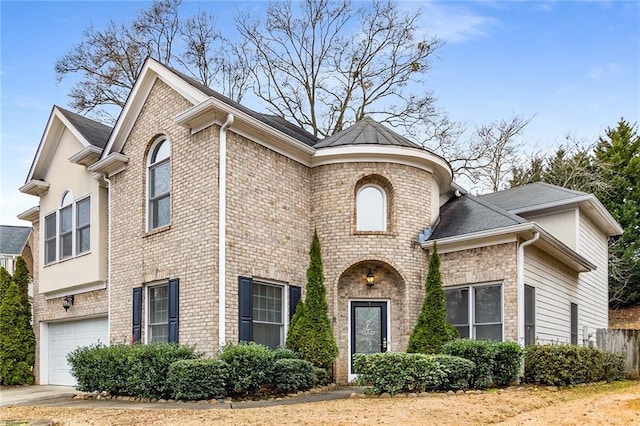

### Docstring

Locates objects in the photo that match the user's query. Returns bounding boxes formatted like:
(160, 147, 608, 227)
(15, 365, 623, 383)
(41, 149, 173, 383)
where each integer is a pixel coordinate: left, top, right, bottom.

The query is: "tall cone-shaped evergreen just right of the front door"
(407, 243, 451, 354)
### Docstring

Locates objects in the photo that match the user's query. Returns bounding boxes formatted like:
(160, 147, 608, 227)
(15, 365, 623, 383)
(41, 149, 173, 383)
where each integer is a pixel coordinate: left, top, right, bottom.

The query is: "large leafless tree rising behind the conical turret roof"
(236, 0, 442, 136)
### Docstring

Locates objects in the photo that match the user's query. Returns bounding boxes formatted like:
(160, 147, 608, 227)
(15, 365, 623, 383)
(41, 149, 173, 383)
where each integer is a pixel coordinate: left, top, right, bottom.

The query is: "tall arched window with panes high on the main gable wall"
(147, 137, 171, 230)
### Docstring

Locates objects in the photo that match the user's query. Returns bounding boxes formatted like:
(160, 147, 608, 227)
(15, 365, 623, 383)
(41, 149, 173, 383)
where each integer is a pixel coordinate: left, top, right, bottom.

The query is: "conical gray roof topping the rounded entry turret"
(314, 117, 424, 149)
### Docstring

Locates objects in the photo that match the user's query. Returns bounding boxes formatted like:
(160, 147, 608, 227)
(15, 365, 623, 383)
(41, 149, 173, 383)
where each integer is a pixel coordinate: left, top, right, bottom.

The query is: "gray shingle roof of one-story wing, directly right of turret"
(429, 195, 527, 240)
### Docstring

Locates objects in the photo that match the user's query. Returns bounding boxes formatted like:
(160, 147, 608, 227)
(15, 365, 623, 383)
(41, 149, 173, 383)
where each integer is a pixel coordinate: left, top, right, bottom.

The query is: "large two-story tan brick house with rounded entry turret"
(20, 59, 620, 384)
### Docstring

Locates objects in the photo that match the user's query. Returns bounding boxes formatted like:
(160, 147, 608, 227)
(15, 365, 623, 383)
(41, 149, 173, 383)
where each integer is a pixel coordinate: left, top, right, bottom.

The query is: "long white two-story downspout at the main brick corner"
(218, 114, 233, 347)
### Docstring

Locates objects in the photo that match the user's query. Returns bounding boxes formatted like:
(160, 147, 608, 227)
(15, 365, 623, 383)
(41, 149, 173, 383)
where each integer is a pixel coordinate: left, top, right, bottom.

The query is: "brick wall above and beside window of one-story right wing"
(440, 242, 518, 342)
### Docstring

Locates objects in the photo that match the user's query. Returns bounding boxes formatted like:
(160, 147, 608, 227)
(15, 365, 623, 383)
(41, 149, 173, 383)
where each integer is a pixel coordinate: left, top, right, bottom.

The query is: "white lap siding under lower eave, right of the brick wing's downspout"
(524, 247, 584, 344)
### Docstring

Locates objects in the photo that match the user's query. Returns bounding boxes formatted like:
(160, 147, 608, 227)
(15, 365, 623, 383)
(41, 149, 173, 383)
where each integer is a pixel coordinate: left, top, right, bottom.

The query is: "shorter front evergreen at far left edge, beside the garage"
(0, 281, 35, 385)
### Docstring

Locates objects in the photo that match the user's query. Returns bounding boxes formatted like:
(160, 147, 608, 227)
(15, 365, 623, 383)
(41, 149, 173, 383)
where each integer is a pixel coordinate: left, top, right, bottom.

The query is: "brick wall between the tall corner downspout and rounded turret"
(226, 131, 313, 342)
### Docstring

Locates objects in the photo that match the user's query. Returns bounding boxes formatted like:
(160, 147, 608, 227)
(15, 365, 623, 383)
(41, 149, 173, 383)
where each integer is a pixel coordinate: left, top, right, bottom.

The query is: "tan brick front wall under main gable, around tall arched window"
(110, 80, 218, 356)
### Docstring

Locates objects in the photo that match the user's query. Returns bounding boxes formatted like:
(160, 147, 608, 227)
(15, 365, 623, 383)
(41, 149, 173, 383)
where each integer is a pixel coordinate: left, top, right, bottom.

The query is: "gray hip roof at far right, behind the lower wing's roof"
(478, 182, 589, 211)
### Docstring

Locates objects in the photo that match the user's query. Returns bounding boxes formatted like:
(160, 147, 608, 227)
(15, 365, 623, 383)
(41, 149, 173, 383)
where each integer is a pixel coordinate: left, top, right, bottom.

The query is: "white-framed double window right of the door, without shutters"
(444, 284, 502, 342)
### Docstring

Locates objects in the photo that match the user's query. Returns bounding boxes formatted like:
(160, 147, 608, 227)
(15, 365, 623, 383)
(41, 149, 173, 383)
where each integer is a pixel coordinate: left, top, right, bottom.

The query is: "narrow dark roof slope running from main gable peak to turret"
(163, 64, 318, 146)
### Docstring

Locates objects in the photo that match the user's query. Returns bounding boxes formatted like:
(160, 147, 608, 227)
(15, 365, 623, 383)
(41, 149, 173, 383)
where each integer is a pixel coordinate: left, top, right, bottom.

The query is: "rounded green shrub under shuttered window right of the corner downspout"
(220, 342, 275, 396)
